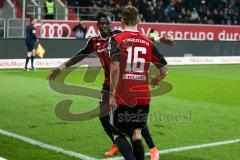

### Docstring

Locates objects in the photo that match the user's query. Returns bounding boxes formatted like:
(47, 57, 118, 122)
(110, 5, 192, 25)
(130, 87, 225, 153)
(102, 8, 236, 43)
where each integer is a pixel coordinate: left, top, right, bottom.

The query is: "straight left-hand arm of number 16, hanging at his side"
(109, 37, 120, 108)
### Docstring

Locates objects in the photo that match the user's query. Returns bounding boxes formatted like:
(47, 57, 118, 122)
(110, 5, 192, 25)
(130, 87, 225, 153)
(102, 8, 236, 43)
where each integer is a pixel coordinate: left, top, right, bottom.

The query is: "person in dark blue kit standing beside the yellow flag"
(24, 18, 37, 71)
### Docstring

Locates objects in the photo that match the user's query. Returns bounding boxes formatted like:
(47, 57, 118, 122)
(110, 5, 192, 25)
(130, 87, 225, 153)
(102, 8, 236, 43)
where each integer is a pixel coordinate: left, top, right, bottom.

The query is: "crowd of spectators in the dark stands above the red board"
(67, 0, 240, 25)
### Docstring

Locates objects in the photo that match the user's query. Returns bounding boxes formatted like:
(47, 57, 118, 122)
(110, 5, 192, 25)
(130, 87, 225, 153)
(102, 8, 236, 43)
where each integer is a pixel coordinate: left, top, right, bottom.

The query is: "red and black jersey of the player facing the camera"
(74, 30, 121, 85)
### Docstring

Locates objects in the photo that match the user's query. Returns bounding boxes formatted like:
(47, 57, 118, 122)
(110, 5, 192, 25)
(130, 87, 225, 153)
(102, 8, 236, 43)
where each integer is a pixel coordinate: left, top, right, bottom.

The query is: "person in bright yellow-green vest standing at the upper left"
(44, 0, 56, 19)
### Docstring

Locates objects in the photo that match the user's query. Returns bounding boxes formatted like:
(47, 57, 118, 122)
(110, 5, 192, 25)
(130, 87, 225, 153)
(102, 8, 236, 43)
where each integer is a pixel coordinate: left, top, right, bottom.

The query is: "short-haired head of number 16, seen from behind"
(122, 6, 139, 26)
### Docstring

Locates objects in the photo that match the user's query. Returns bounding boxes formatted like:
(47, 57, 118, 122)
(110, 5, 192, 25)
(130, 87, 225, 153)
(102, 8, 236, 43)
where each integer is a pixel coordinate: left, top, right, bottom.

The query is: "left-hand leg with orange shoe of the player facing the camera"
(99, 85, 118, 156)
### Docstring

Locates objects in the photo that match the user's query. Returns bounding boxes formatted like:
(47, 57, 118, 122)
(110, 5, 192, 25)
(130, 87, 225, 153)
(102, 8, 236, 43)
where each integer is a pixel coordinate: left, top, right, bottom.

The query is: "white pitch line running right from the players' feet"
(101, 138, 240, 160)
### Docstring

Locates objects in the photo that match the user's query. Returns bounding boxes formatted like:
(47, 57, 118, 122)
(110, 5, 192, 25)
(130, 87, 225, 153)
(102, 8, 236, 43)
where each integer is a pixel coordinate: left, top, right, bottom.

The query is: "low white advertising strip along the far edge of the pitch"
(0, 56, 240, 69)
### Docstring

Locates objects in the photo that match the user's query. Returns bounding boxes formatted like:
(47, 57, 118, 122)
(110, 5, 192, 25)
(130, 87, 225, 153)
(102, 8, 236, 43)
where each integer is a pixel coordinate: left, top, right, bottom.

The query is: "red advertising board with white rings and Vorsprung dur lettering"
(34, 21, 240, 41)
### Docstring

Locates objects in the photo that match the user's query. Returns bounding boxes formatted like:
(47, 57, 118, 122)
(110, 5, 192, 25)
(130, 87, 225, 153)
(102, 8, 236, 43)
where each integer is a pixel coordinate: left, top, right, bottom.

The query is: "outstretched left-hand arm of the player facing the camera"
(48, 38, 94, 80)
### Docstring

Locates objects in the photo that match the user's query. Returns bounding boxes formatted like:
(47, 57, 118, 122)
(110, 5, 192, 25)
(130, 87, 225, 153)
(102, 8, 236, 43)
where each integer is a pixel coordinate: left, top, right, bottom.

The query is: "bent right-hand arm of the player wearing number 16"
(150, 45, 168, 88)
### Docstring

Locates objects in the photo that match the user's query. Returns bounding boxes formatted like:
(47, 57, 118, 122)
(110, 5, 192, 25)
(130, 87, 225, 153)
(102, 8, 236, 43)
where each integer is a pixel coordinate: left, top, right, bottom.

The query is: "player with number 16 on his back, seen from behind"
(109, 6, 167, 160)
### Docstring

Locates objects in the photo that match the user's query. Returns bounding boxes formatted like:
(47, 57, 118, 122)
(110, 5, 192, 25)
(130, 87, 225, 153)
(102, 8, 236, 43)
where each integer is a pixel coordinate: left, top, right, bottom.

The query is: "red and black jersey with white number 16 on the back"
(110, 31, 167, 106)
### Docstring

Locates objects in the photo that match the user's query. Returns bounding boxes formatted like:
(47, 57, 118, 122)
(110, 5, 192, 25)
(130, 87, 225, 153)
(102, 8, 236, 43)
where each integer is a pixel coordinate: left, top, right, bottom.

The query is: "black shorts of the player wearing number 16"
(110, 105, 149, 137)
